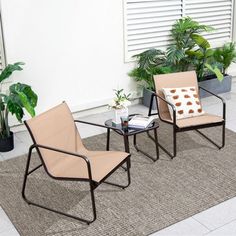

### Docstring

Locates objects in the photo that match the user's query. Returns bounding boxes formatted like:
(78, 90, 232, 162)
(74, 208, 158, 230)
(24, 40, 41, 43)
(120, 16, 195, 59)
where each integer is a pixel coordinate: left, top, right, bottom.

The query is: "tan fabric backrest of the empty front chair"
(25, 102, 84, 173)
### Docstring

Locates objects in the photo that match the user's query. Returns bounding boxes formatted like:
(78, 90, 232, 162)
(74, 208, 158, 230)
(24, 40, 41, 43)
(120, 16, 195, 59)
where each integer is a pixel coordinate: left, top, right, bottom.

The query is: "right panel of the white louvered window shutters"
(184, 0, 233, 47)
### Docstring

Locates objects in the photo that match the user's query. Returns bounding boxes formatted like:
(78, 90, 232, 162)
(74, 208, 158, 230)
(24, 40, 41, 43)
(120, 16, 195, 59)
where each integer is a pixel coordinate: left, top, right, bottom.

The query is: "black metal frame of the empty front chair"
(22, 120, 131, 225)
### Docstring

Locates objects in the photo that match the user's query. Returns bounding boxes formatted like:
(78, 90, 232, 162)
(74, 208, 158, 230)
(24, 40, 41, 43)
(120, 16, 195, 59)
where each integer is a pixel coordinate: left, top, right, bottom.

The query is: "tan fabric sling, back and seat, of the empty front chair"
(27, 103, 129, 182)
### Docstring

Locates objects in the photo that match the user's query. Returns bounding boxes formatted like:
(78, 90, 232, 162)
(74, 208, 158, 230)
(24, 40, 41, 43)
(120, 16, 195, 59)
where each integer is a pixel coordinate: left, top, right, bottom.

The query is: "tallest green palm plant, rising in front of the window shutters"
(167, 17, 213, 71)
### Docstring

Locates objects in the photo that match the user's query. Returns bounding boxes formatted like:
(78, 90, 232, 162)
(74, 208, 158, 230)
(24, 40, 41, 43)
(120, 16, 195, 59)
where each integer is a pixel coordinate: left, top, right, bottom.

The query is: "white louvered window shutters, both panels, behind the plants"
(123, 0, 234, 62)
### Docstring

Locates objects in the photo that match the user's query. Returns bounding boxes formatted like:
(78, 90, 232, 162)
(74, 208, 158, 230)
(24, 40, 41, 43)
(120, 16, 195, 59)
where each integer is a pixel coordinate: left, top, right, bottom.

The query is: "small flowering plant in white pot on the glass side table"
(109, 89, 131, 124)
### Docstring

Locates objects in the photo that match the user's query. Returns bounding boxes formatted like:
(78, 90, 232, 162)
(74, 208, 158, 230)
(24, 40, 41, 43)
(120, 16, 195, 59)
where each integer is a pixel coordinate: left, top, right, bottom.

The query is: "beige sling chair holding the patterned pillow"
(149, 71, 226, 158)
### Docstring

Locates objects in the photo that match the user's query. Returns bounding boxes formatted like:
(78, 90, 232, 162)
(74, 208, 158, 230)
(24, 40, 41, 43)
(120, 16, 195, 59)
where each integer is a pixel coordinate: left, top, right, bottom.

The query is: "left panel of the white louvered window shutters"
(124, 0, 182, 61)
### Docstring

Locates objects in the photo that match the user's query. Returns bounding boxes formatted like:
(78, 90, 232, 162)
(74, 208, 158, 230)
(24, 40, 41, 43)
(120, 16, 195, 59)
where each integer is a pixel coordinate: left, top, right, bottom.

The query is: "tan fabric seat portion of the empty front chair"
(50, 149, 129, 182)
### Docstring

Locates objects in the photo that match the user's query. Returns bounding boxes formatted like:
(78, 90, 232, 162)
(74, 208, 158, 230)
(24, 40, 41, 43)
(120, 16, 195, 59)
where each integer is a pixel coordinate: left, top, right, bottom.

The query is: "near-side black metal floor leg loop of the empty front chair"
(22, 147, 97, 225)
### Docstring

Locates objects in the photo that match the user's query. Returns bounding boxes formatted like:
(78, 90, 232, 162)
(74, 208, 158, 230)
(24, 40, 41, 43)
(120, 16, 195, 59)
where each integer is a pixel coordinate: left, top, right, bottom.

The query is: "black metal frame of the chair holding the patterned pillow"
(148, 86, 226, 159)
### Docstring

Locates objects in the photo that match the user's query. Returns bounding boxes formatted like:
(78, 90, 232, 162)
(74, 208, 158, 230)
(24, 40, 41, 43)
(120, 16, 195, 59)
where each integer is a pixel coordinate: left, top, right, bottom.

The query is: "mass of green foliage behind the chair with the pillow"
(129, 17, 236, 86)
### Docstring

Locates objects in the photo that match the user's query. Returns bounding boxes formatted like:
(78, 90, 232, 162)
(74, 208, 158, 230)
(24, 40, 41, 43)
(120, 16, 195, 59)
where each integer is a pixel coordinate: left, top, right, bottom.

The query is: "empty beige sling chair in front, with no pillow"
(22, 102, 130, 224)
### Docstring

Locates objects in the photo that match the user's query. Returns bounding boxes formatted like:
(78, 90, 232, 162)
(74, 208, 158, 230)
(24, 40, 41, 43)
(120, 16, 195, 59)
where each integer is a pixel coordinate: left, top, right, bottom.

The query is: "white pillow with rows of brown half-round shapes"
(162, 87, 205, 119)
